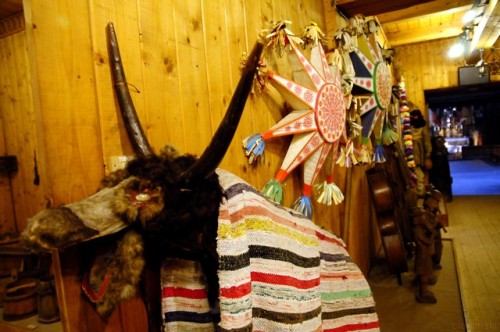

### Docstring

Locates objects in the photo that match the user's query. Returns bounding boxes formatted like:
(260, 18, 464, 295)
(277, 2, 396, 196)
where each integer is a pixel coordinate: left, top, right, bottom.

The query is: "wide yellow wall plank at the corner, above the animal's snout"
(25, 0, 103, 204)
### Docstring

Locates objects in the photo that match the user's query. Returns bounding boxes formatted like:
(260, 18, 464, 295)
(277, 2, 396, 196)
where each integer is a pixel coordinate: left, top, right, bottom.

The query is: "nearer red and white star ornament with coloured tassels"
(243, 22, 346, 217)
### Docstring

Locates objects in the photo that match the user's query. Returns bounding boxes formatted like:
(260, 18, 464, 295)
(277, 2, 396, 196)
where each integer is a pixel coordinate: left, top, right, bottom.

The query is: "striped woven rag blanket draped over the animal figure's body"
(162, 170, 379, 332)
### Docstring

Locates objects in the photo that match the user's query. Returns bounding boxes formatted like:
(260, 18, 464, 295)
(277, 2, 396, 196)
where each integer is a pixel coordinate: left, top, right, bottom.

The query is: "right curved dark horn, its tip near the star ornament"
(181, 42, 264, 182)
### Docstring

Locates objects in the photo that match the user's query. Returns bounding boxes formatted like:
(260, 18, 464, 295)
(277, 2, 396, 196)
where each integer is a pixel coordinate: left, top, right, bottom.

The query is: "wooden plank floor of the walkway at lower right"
(443, 196, 500, 332)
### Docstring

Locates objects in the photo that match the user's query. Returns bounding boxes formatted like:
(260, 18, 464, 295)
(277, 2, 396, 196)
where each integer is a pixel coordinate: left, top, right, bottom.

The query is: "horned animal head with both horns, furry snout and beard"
(22, 23, 263, 316)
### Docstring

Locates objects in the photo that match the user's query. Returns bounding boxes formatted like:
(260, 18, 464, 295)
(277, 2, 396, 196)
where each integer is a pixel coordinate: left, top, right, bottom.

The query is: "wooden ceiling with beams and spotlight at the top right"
(336, 0, 500, 49)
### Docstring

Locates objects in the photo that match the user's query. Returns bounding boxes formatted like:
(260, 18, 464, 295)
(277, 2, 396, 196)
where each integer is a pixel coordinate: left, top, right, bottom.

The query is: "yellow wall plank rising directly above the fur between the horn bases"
(138, 1, 185, 151)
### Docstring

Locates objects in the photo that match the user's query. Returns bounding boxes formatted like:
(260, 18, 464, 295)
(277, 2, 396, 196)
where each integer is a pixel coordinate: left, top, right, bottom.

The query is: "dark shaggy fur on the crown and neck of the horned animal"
(103, 147, 223, 305)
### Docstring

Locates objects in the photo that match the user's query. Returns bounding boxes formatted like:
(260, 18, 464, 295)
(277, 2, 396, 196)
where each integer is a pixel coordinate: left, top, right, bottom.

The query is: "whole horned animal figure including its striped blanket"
(23, 24, 379, 331)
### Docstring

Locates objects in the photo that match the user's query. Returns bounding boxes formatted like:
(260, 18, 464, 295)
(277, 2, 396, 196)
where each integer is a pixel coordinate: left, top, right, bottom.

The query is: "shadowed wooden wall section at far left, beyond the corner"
(0, 31, 47, 233)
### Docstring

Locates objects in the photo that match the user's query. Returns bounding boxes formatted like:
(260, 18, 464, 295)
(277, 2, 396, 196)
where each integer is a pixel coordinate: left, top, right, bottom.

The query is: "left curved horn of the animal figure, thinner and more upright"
(106, 22, 153, 157)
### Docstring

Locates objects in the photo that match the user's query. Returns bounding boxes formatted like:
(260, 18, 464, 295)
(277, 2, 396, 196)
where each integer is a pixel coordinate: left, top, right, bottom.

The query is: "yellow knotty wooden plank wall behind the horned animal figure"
(0, 0, 376, 331)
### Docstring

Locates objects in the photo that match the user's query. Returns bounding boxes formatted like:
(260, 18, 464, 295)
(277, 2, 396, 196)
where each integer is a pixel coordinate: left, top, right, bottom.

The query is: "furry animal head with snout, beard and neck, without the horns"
(22, 146, 223, 316)
